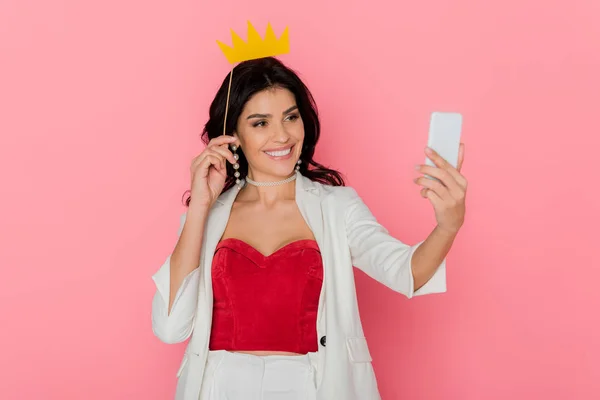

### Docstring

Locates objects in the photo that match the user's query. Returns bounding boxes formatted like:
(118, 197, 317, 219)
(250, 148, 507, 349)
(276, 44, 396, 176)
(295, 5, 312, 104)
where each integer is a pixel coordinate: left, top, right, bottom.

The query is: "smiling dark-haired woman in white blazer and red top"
(152, 58, 466, 400)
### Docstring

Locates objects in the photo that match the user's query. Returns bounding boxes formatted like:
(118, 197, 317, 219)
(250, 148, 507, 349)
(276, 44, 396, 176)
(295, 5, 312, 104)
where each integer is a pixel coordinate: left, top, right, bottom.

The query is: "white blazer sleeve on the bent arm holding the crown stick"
(152, 214, 200, 344)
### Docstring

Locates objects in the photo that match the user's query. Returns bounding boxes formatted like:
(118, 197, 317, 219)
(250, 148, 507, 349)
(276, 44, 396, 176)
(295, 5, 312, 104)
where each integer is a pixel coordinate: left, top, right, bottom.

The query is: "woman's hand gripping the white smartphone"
(414, 143, 467, 235)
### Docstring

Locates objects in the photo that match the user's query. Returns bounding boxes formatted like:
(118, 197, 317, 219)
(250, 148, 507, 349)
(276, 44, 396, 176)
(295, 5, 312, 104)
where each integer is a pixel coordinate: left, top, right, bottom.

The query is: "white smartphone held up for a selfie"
(425, 111, 462, 179)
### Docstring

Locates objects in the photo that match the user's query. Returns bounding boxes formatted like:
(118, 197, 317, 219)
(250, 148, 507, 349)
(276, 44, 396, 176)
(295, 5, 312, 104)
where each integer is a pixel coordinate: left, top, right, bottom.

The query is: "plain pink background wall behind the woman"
(0, 0, 600, 400)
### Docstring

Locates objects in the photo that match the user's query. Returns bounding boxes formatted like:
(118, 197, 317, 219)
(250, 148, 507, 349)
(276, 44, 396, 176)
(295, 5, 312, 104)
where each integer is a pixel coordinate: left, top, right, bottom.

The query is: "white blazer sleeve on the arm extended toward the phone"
(345, 188, 446, 299)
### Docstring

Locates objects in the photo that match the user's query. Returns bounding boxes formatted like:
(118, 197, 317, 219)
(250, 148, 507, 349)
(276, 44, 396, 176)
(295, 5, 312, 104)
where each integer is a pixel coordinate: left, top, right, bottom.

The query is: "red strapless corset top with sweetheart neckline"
(209, 239, 323, 354)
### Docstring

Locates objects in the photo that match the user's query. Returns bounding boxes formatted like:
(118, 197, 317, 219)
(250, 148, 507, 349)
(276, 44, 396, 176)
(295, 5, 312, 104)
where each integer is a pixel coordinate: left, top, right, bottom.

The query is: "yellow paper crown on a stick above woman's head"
(217, 21, 290, 64)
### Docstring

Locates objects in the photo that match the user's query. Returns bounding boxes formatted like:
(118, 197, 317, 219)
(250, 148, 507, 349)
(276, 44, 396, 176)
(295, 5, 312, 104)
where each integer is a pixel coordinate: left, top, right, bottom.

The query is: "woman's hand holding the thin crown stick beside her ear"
(190, 135, 237, 209)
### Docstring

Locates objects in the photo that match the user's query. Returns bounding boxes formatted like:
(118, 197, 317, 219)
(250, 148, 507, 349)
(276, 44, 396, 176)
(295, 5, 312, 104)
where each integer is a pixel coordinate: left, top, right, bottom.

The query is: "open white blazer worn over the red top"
(152, 174, 446, 400)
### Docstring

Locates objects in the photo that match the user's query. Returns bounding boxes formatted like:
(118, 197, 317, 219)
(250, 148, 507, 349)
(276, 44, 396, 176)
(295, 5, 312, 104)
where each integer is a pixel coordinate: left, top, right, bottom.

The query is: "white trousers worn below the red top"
(199, 350, 317, 400)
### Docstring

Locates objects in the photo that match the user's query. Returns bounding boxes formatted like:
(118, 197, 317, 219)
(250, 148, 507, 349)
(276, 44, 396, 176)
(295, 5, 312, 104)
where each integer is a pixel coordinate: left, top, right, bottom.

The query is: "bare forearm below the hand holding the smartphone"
(411, 226, 456, 290)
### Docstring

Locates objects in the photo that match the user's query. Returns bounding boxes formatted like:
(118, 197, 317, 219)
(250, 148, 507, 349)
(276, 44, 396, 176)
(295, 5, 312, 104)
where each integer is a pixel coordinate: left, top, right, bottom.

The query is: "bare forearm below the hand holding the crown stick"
(169, 204, 208, 313)
